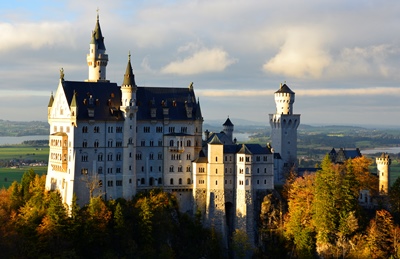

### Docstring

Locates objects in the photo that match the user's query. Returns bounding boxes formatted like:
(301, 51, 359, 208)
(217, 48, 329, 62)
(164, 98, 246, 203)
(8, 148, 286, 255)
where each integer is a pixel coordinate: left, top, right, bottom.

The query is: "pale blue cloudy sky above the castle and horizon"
(0, 0, 400, 126)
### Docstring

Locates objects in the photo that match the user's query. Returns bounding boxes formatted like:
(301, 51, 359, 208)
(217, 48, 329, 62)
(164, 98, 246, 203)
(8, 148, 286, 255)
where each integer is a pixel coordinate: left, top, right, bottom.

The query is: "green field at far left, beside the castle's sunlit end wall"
(0, 145, 49, 188)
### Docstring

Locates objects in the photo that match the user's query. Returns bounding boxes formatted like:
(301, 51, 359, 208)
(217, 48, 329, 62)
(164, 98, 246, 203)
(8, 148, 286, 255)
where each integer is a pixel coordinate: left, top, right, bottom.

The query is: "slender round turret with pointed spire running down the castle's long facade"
(120, 53, 138, 199)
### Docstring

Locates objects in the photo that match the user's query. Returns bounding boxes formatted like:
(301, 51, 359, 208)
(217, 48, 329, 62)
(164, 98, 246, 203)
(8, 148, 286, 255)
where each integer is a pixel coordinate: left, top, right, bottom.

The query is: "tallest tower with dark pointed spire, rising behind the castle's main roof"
(86, 14, 108, 82)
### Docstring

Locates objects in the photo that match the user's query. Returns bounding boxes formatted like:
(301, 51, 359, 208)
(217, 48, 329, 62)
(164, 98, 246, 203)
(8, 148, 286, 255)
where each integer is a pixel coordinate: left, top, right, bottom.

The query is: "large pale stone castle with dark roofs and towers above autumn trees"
(46, 15, 300, 246)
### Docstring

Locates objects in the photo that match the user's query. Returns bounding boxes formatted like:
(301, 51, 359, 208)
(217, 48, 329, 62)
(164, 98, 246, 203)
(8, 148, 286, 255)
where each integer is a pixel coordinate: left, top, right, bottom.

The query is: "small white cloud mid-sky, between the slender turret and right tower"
(161, 48, 237, 75)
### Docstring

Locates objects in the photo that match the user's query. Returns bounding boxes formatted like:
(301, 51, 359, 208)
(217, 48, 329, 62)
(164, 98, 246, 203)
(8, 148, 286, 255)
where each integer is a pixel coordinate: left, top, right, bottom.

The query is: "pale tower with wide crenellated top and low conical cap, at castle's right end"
(269, 84, 300, 184)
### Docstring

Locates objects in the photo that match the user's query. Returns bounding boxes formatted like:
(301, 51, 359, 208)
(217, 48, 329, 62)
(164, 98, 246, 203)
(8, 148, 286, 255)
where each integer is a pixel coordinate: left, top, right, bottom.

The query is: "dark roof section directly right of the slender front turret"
(136, 86, 202, 121)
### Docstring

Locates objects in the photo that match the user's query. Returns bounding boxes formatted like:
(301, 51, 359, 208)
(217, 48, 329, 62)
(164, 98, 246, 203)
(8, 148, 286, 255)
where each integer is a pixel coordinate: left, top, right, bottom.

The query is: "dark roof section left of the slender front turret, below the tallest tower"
(61, 81, 124, 121)
